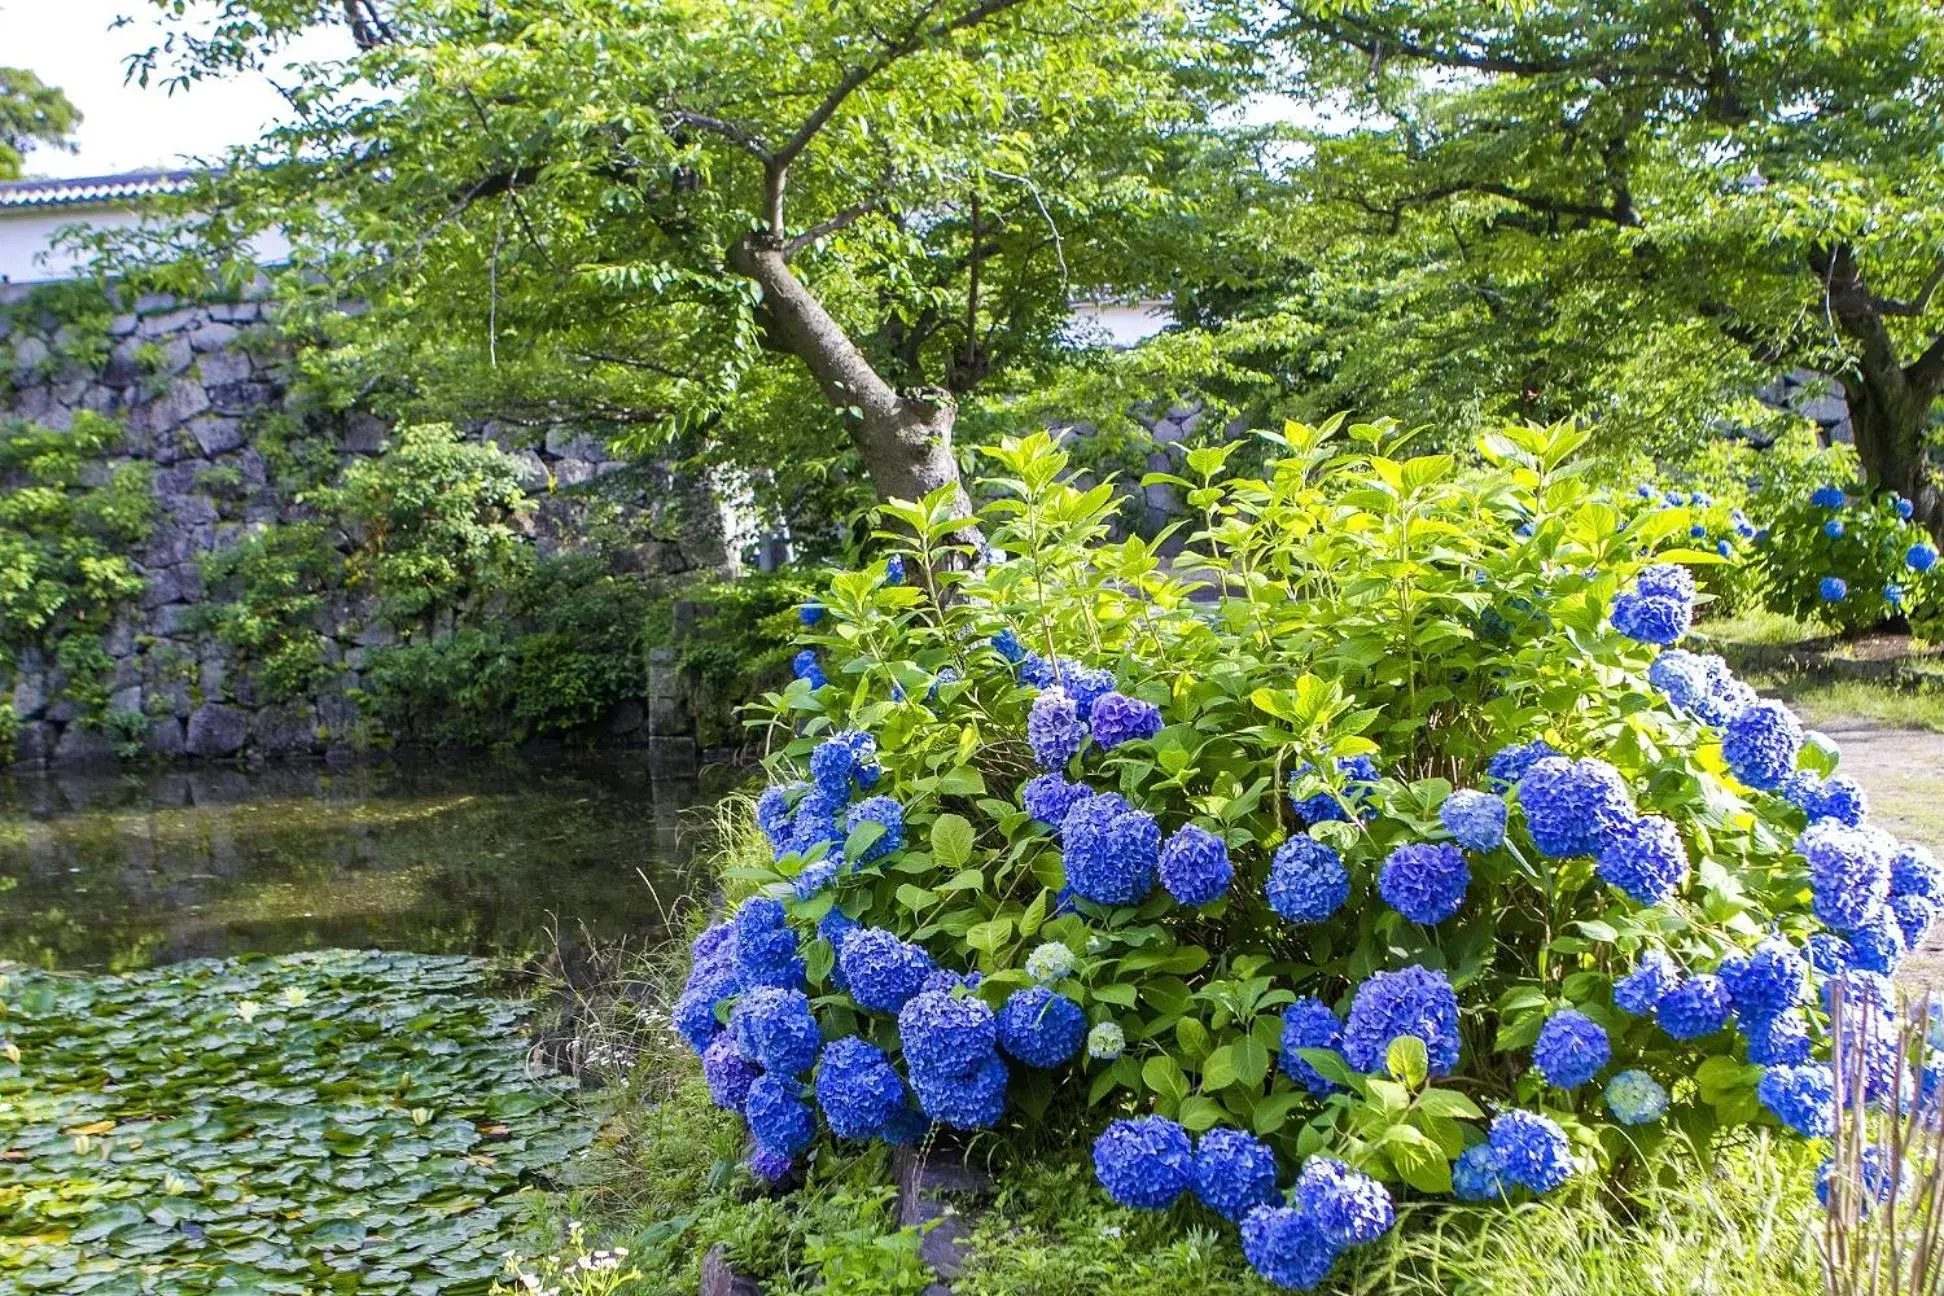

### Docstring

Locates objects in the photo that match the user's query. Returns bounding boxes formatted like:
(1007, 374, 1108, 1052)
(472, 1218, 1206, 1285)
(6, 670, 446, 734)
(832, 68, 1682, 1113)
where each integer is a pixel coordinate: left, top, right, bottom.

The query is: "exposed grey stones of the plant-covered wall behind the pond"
(0, 286, 733, 764)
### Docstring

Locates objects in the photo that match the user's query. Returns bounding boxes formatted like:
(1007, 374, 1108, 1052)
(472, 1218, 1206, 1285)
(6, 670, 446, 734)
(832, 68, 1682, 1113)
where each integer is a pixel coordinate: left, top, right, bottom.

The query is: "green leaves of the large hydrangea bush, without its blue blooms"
(737, 417, 1850, 1227)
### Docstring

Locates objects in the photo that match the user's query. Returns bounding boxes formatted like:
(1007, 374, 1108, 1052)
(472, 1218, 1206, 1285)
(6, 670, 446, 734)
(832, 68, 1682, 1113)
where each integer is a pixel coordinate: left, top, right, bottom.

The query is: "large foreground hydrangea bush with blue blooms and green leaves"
(675, 426, 1938, 1290)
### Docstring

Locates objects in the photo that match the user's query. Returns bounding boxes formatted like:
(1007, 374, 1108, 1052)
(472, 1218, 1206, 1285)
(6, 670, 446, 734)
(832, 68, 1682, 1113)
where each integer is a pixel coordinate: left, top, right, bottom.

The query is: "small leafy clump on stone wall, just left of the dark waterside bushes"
(198, 523, 342, 701)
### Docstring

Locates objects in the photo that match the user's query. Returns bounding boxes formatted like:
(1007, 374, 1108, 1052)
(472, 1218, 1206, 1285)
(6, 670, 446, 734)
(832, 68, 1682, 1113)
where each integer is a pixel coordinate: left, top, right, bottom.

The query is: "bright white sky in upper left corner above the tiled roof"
(0, 0, 342, 177)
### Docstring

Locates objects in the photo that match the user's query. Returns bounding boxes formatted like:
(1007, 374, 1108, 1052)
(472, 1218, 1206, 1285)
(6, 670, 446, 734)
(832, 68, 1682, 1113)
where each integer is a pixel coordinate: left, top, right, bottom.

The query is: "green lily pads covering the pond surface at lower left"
(0, 950, 593, 1294)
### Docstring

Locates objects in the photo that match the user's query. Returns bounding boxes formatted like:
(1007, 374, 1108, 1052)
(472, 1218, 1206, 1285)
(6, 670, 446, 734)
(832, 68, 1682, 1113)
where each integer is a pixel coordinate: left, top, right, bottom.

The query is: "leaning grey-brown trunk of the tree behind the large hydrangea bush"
(729, 233, 978, 542)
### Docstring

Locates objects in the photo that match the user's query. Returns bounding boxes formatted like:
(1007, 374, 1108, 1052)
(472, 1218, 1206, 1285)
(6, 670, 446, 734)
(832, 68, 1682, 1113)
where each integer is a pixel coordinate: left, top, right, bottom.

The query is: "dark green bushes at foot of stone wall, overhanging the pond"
(364, 554, 649, 746)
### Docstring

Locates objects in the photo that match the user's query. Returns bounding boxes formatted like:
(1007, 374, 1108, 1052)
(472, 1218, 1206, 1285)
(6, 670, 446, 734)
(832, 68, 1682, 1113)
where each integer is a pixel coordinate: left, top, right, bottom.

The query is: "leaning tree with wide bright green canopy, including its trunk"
(94, 0, 1238, 540)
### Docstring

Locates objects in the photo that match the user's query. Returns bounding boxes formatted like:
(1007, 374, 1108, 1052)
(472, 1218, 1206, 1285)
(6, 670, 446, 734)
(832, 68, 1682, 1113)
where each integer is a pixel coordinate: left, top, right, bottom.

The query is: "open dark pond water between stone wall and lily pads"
(0, 754, 719, 970)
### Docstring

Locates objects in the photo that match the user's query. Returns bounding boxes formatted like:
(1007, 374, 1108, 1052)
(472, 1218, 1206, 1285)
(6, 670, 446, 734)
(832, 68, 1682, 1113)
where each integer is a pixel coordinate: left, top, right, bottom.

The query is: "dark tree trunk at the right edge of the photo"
(1810, 243, 1944, 536)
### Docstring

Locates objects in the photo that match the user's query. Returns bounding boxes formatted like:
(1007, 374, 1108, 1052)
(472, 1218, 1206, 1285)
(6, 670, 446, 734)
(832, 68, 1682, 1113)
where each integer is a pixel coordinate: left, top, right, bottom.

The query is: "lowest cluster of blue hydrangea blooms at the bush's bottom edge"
(1093, 1115, 1398, 1292)
